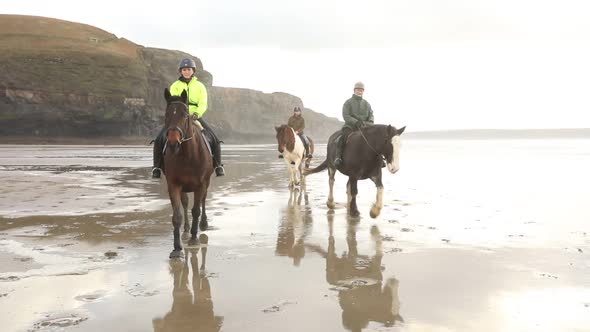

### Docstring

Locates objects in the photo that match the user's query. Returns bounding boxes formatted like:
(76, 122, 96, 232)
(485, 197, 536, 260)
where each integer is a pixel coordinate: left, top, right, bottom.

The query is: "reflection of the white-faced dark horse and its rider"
(308, 214, 403, 331)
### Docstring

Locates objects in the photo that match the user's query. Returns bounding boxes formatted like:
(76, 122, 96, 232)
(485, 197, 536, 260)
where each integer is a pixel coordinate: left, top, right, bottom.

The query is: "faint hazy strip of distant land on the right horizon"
(404, 128, 590, 139)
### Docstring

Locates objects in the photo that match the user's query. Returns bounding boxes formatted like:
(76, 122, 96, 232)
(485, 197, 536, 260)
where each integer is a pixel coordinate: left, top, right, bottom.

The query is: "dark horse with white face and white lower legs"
(304, 125, 406, 218)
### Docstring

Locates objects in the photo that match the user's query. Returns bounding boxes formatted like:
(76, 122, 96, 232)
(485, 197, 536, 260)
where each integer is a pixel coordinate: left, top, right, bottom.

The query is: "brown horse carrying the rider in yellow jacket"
(164, 89, 213, 258)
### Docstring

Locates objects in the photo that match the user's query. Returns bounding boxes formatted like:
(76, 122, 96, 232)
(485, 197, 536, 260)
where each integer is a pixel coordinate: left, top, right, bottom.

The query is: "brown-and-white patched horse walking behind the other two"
(275, 125, 314, 187)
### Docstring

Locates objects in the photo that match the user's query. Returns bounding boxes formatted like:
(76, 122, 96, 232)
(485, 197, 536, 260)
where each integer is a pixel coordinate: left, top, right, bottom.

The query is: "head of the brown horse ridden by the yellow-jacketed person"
(164, 89, 193, 153)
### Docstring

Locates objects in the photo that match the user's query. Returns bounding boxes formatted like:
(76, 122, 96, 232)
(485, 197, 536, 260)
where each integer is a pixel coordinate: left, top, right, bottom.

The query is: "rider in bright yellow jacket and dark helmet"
(152, 59, 225, 178)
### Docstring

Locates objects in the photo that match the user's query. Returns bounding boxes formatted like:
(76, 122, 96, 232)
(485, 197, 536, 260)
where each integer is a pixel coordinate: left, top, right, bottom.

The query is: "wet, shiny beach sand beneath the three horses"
(0, 140, 590, 331)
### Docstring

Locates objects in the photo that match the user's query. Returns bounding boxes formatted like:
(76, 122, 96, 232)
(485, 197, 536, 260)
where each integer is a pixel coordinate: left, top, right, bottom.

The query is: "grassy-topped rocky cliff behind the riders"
(0, 15, 341, 143)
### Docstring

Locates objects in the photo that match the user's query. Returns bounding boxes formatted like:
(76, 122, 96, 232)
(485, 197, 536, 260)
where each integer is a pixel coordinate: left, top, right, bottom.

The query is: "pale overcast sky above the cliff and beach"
(0, 0, 590, 131)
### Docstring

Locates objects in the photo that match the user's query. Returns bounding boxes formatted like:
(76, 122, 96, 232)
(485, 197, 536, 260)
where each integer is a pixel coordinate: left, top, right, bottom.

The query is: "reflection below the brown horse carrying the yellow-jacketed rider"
(152, 234, 223, 332)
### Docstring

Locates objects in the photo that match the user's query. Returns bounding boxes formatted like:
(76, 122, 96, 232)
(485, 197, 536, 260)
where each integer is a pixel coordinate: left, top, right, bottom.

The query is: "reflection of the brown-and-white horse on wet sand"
(275, 186, 313, 266)
